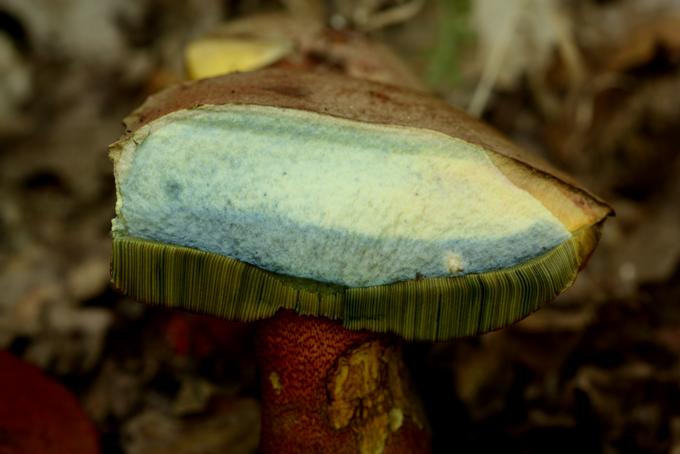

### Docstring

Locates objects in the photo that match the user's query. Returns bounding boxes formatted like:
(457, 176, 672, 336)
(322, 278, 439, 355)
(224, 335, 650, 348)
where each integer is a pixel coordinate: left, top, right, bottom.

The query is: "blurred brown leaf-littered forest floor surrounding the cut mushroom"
(0, 0, 680, 454)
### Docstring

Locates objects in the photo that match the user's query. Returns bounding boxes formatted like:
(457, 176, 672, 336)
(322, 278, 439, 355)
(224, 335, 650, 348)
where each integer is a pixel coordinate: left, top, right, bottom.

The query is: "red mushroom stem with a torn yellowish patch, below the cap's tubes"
(257, 310, 430, 454)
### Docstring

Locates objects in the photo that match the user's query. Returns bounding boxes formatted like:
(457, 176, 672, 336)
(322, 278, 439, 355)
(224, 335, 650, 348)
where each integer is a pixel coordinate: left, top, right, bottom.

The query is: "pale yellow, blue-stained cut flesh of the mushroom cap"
(114, 105, 571, 287)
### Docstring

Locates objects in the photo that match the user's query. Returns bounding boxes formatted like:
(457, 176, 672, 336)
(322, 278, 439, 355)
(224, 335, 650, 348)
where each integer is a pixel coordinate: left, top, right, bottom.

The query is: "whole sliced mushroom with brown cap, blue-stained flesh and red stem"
(111, 70, 611, 453)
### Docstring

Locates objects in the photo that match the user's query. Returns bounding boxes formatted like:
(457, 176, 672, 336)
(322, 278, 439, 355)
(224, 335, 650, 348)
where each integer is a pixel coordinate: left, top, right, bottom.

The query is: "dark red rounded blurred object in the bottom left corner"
(0, 351, 99, 454)
